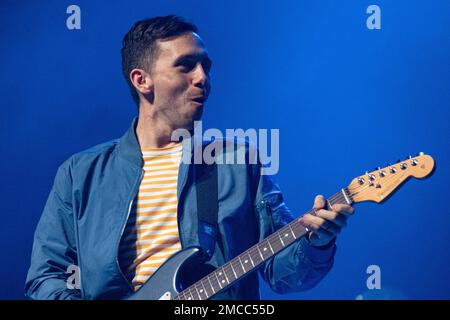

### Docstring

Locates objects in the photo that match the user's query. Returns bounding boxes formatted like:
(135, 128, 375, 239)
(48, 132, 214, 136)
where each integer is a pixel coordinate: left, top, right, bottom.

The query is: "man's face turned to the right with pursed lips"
(151, 32, 212, 129)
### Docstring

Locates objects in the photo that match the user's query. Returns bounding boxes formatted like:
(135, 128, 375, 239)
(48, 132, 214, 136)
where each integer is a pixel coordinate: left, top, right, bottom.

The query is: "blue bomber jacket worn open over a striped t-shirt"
(25, 119, 336, 300)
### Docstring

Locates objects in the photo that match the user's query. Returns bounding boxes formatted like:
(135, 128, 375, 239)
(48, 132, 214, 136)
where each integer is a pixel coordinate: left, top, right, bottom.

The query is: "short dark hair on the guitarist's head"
(121, 15, 198, 106)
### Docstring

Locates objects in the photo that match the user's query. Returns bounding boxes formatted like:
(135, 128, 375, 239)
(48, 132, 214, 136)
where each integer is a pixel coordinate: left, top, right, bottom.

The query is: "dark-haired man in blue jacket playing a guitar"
(26, 16, 353, 299)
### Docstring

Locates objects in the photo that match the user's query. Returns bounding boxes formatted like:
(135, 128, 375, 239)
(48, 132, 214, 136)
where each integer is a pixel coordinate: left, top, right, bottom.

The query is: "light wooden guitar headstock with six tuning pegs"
(347, 152, 434, 203)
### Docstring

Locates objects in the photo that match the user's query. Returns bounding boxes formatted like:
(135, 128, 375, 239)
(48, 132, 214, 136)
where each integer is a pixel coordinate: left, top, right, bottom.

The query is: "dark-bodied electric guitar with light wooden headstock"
(127, 152, 434, 300)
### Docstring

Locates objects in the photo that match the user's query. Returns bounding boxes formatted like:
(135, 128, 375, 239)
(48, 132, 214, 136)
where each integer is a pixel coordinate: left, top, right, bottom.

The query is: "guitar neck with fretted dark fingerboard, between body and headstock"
(174, 188, 353, 300)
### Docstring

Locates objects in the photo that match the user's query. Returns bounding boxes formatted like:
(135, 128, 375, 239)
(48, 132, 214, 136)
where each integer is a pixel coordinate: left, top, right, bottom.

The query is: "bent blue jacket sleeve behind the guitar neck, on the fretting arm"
(253, 161, 336, 293)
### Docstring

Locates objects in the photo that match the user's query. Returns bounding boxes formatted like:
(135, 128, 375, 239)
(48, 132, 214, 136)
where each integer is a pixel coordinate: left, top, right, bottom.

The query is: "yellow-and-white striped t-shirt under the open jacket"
(119, 143, 182, 290)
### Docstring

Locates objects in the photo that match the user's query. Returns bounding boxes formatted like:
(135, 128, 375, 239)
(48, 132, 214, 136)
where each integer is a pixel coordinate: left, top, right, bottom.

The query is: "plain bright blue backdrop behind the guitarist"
(0, 0, 450, 299)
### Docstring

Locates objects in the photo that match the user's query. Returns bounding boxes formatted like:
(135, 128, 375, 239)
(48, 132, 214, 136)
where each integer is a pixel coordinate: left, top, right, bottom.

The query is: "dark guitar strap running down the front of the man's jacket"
(194, 161, 219, 259)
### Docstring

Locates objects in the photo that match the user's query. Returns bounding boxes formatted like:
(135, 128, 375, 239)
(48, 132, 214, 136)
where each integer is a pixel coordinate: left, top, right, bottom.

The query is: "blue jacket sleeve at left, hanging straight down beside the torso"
(25, 160, 81, 300)
